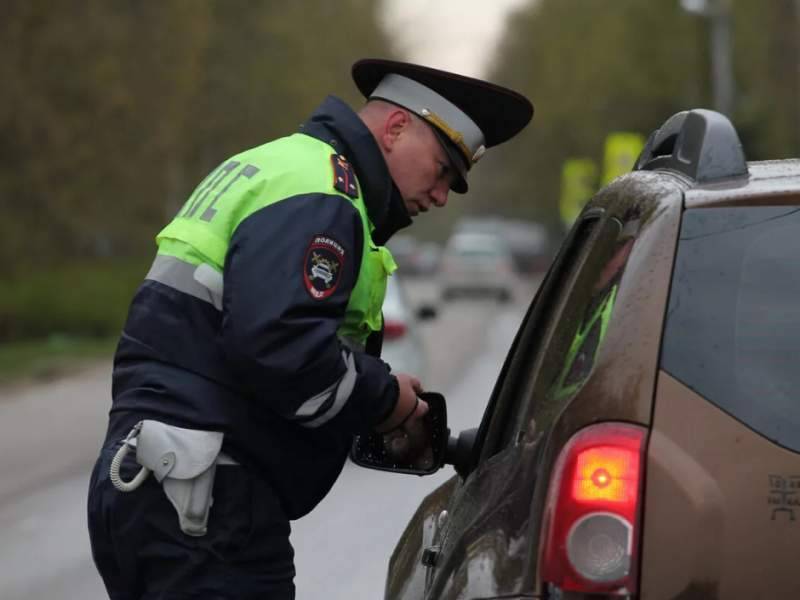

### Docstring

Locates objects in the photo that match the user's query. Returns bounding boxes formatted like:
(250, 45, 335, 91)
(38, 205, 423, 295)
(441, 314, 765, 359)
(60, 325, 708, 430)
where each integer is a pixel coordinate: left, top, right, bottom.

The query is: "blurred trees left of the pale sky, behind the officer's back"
(0, 0, 390, 270)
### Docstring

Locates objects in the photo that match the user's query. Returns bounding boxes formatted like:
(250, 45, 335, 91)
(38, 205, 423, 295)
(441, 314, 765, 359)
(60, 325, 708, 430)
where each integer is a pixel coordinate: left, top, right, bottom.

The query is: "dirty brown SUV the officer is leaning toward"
(354, 110, 800, 600)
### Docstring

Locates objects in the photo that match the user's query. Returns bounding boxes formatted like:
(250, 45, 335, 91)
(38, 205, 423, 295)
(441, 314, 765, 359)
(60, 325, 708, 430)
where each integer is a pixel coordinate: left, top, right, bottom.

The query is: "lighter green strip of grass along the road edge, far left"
(0, 335, 117, 385)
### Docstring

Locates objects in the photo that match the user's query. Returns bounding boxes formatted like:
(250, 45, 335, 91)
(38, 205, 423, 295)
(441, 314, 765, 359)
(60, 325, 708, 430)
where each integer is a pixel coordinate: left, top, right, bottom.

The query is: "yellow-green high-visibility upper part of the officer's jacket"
(156, 133, 397, 348)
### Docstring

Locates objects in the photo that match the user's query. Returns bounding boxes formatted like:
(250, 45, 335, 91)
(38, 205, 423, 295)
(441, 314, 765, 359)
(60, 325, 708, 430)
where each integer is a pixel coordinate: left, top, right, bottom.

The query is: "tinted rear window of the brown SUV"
(661, 206, 800, 451)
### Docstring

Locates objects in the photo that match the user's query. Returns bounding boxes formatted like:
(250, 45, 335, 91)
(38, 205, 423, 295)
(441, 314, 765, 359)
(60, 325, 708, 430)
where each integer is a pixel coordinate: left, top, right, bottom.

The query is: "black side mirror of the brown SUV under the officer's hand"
(350, 392, 450, 475)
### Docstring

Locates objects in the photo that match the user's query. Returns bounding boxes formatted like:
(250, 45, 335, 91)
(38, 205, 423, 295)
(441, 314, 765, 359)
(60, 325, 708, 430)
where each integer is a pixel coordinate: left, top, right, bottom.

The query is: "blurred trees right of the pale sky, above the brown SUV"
(470, 0, 800, 234)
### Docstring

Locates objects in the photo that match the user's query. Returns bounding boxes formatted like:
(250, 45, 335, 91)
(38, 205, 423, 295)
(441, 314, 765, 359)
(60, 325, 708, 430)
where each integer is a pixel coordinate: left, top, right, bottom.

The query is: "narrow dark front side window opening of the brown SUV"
(478, 213, 602, 460)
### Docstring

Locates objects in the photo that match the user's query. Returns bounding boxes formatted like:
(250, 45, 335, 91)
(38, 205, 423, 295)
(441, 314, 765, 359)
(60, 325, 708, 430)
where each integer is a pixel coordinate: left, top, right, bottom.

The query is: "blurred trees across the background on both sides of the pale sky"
(0, 0, 800, 288)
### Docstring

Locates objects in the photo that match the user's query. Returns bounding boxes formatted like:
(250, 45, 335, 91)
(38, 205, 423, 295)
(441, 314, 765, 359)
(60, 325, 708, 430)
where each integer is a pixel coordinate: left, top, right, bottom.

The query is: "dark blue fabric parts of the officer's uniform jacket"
(108, 97, 411, 519)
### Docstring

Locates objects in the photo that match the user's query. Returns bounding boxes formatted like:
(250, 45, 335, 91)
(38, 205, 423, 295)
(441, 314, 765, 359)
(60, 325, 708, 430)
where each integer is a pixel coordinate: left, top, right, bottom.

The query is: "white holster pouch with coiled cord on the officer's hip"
(110, 420, 231, 536)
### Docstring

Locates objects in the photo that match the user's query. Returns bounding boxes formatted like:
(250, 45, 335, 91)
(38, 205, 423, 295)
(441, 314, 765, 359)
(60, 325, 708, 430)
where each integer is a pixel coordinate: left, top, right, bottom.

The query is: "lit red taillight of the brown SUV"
(539, 423, 646, 595)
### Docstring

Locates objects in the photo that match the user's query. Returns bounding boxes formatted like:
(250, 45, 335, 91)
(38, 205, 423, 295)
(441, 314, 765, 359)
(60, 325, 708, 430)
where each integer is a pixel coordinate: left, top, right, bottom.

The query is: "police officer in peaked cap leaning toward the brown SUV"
(88, 59, 533, 599)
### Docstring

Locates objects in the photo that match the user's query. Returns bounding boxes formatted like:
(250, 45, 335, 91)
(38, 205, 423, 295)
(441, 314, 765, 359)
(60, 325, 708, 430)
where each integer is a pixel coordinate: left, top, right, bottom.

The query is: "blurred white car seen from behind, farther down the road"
(441, 231, 516, 302)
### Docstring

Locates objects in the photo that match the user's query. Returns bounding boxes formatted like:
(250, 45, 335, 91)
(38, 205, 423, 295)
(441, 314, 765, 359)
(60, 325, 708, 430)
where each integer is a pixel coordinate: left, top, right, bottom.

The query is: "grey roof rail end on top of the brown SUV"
(634, 108, 748, 182)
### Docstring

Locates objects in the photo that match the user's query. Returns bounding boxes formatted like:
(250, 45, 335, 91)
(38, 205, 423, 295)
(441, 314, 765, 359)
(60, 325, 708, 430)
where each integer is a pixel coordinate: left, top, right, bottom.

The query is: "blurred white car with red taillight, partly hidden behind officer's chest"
(381, 273, 436, 381)
